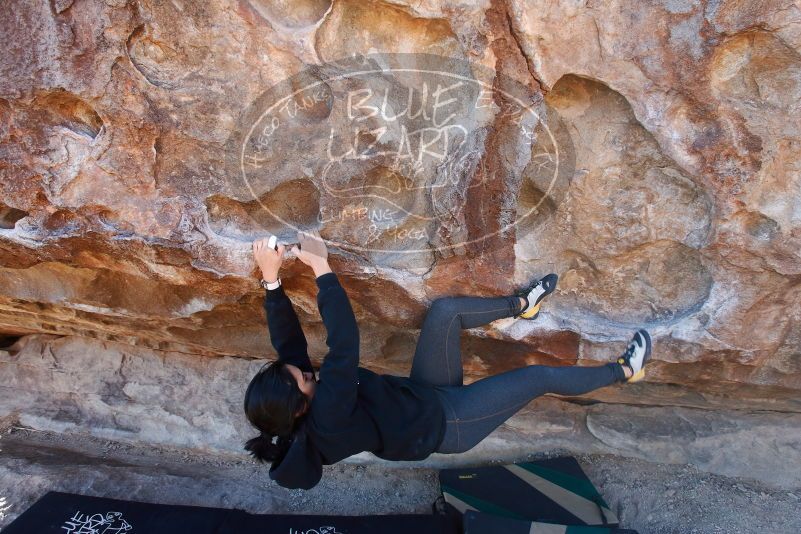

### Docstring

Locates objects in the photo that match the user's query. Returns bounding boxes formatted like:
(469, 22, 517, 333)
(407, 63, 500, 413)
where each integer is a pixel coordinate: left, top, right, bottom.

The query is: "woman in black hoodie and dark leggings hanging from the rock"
(244, 232, 651, 489)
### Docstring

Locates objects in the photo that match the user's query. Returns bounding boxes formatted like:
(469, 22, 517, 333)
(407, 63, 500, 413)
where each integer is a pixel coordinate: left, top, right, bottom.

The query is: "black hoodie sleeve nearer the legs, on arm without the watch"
(311, 272, 359, 428)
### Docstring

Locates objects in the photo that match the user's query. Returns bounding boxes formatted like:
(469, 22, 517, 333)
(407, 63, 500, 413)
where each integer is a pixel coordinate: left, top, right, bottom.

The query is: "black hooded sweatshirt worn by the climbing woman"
(264, 272, 445, 489)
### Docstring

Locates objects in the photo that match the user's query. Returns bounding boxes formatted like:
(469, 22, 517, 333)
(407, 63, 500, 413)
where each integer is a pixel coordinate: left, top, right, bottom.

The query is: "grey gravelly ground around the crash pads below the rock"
(0, 428, 801, 534)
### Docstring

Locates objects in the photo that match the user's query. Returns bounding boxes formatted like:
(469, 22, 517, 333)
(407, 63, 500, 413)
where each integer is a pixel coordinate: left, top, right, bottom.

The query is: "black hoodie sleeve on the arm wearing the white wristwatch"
(264, 286, 314, 372)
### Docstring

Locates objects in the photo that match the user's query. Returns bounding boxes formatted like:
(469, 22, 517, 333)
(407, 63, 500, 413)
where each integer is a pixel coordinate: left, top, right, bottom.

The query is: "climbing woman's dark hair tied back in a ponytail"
(245, 361, 309, 462)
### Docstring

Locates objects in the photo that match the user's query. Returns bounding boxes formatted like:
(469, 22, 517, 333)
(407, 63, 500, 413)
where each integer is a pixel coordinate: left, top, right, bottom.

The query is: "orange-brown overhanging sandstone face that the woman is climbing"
(0, 0, 801, 484)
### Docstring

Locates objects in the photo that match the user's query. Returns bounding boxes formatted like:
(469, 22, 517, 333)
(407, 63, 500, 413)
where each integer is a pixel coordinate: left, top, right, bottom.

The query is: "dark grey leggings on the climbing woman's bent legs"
(410, 296, 626, 454)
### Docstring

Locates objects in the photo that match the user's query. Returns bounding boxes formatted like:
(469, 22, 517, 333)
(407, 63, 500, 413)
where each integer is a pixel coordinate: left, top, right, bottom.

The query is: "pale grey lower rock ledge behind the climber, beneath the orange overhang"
(0, 334, 801, 488)
